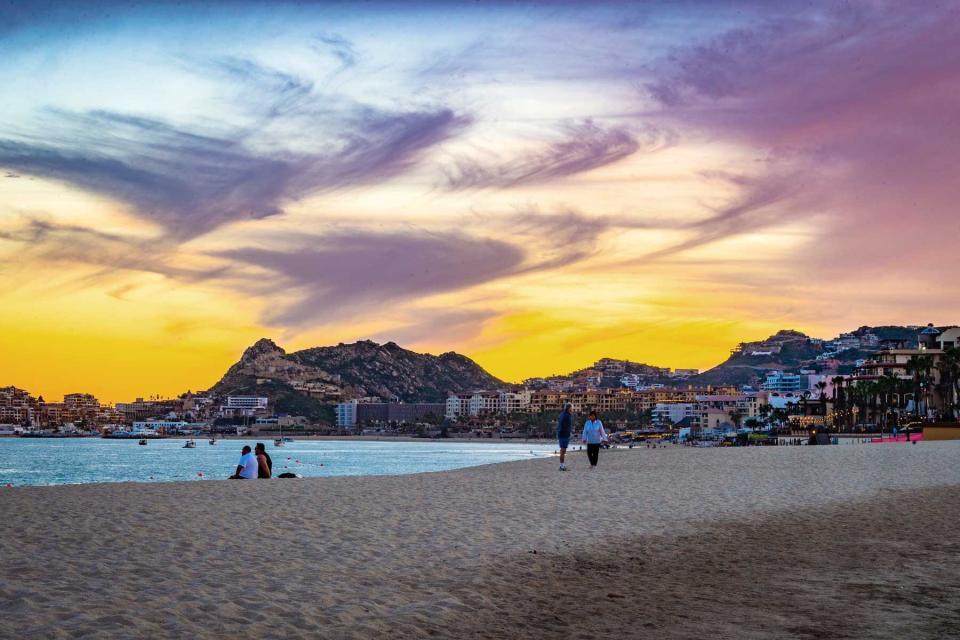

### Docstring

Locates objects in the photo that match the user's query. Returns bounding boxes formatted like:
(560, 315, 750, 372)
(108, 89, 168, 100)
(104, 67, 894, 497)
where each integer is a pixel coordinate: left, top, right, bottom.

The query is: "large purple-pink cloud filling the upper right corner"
(647, 2, 960, 276)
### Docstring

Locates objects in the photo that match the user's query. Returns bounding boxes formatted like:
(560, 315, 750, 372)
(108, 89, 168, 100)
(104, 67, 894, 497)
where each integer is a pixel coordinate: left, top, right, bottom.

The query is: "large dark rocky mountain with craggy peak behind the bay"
(208, 338, 509, 416)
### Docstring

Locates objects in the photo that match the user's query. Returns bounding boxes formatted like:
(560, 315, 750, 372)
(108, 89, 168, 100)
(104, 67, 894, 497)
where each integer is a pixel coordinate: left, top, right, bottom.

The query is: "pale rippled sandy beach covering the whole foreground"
(0, 443, 960, 638)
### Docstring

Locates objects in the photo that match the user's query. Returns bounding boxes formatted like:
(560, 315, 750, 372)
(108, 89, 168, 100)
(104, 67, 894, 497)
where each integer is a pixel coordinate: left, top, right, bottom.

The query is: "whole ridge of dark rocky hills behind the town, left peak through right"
(208, 326, 932, 419)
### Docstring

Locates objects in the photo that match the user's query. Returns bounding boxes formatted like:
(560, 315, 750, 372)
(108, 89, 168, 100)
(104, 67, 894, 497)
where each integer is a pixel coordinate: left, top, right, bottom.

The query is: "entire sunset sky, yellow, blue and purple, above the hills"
(0, 0, 960, 401)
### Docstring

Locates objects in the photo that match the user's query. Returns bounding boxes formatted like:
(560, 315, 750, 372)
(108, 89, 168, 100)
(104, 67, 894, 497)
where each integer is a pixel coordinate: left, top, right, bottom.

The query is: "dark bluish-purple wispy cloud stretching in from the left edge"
(0, 59, 468, 239)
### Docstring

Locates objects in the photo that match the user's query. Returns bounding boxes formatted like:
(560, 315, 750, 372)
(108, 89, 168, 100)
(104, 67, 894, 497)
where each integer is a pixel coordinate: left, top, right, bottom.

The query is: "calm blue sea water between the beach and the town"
(0, 438, 556, 487)
